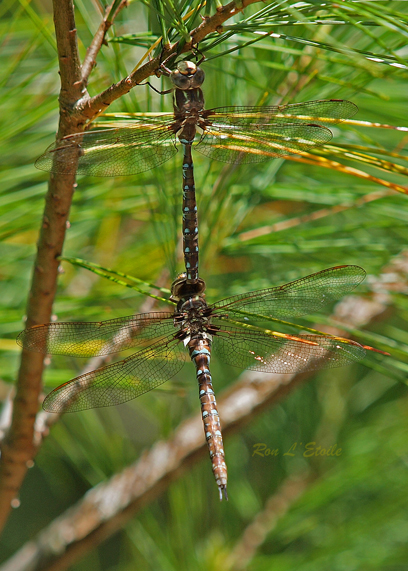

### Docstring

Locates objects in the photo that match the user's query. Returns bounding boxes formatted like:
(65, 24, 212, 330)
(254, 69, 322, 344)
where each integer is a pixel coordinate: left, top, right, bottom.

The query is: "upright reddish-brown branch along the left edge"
(0, 0, 83, 530)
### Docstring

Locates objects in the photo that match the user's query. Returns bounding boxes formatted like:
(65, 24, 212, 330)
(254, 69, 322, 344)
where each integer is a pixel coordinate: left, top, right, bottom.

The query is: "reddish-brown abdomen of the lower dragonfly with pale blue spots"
(188, 338, 228, 500)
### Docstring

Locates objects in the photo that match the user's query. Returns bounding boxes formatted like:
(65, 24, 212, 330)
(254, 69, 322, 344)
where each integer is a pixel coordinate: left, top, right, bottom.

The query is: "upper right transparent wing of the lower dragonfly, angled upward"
(211, 266, 366, 323)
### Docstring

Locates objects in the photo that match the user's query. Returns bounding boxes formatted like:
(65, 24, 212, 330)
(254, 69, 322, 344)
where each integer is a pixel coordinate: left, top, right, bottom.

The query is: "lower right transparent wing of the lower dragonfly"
(213, 327, 365, 373)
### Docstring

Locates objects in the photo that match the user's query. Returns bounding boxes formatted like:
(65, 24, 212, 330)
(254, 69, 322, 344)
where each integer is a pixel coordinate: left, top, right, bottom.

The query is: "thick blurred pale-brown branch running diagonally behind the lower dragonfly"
(0, 259, 398, 571)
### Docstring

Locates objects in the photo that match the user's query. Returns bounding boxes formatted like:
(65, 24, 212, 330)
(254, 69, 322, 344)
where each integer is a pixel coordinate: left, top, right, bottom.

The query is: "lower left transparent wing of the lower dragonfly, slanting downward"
(43, 338, 186, 412)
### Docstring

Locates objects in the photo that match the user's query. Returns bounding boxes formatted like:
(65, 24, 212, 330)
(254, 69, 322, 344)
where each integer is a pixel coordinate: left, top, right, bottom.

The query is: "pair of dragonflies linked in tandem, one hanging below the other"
(23, 62, 365, 499)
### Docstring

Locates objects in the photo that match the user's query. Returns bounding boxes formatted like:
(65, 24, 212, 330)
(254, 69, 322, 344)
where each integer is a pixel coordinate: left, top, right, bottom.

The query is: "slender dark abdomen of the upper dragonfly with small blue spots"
(182, 140, 198, 283)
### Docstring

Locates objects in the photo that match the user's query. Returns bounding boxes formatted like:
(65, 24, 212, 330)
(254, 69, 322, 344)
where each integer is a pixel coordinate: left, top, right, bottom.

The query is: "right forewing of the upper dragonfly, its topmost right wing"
(205, 99, 358, 129)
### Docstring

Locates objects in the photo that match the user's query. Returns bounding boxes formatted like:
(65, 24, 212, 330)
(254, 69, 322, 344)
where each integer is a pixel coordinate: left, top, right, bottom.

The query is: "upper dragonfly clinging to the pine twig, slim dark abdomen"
(35, 61, 358, 283)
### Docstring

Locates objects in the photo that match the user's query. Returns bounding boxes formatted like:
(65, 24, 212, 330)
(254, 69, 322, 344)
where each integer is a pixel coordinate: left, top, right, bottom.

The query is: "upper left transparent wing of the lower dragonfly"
(17, 312, 175, 357)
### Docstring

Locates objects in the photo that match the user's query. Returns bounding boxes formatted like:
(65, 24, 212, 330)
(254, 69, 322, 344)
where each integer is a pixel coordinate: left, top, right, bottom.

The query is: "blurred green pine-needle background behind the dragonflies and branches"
(0, 0, 408, 571)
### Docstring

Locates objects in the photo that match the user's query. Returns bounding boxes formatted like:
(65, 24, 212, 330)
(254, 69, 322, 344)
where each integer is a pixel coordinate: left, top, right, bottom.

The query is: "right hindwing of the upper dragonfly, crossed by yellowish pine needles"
(195, 122, 332, 164)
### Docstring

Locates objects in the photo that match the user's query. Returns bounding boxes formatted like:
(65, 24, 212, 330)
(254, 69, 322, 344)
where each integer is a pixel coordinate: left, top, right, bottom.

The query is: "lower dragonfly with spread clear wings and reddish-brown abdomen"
(17, 265, 365, 500)
